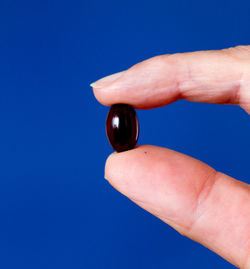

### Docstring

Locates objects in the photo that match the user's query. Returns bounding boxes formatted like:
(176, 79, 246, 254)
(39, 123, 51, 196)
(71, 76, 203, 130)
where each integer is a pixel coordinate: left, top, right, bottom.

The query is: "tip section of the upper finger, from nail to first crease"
(91, 55, 181, 109)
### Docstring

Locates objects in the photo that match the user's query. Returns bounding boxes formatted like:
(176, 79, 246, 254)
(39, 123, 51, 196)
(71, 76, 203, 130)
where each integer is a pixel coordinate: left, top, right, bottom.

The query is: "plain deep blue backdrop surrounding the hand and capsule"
(0, 0, 250, 269)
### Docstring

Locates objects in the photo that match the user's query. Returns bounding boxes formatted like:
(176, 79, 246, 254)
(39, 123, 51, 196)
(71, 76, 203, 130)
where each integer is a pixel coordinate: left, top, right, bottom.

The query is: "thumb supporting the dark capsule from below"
(105, 146, 250, 269)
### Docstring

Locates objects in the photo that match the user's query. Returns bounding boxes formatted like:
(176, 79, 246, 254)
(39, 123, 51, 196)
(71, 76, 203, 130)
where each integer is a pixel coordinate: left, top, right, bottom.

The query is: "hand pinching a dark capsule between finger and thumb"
(91, 46, 250, 269)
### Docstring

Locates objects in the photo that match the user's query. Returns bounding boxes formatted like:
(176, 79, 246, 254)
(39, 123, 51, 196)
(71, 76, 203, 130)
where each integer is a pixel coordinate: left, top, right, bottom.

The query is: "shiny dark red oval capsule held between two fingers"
(106, 104, 139, 152)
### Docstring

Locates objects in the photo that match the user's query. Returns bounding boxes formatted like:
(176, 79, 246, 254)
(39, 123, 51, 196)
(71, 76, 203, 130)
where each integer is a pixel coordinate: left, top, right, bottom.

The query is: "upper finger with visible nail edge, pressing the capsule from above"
(91, 46, 250, 113)
